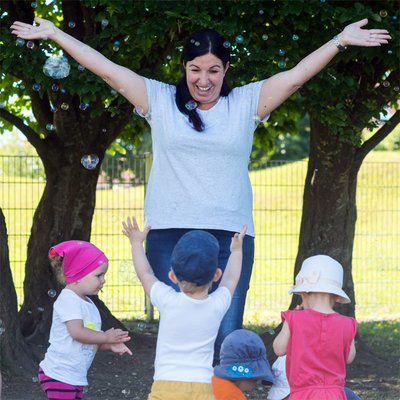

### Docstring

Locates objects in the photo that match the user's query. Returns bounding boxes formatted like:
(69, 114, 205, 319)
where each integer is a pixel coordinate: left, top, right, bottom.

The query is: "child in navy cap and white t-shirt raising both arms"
(122, 218, 247, 400)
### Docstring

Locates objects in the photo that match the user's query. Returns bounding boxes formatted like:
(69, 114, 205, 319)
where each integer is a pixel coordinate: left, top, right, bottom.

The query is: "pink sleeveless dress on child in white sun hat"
(282, 309, 357, 400)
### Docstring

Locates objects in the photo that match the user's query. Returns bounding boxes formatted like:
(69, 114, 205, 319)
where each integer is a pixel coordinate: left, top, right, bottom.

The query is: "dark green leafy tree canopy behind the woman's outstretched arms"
(0, 0, 400, 150)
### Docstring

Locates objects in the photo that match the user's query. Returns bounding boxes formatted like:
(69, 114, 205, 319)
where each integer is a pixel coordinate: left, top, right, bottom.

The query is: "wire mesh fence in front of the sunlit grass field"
(0, 155, 400, 323)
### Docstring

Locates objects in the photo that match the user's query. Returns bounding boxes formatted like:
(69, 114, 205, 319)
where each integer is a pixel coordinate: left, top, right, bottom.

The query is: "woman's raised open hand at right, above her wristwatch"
(339, 18, 391, 47)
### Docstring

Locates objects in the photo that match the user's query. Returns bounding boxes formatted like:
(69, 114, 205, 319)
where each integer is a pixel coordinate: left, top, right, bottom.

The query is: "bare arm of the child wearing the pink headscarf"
(66, 319, 131, 345)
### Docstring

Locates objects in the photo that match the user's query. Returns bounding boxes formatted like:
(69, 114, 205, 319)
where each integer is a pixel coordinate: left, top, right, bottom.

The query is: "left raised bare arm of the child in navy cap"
(122, 217, 158, 295)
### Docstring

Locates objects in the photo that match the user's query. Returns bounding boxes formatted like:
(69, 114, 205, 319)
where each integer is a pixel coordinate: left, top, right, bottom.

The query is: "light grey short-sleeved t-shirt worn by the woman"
(145, 78, 263, 236)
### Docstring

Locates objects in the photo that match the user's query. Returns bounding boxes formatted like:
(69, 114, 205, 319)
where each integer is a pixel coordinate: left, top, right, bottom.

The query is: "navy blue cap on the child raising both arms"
(171, 230, 219, 286)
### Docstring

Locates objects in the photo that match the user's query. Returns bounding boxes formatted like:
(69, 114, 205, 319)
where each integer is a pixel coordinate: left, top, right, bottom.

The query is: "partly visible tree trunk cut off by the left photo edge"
(0, 208, 36, 374)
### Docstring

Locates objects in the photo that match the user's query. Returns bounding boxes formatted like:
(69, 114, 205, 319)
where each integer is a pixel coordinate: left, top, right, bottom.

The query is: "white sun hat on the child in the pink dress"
(289, 255, 350, 303)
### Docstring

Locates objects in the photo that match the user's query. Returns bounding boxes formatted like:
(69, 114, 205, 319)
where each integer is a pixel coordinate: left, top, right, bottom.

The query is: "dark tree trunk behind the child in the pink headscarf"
(20, 135, 126, 345)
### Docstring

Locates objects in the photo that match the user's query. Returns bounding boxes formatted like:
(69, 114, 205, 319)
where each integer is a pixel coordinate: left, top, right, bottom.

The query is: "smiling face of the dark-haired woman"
(185, 53, 229, 110)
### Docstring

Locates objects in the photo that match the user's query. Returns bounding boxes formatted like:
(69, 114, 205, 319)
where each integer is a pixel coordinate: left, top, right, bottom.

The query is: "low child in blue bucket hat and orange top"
(212, 329, 275, 400)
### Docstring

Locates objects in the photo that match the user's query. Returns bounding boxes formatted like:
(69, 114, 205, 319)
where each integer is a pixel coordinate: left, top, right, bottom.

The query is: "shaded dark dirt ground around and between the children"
(1, 332, 400, 400)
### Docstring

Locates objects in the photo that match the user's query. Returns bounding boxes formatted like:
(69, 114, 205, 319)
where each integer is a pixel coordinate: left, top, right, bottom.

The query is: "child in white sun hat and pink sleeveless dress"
(273, 255, 357, 400)
